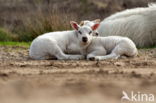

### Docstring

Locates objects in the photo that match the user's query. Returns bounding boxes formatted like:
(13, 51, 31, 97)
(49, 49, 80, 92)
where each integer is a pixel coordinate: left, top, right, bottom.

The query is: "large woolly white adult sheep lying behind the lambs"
(80, 4, 156, 47)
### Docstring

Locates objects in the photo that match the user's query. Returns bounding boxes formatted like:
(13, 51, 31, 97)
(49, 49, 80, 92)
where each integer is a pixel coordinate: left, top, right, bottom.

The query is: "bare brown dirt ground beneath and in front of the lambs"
(0, 46, 156, 103)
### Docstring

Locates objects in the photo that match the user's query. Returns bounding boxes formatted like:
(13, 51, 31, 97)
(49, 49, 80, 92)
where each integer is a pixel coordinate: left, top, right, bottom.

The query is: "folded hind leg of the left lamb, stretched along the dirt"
(50, 45, 84, 60)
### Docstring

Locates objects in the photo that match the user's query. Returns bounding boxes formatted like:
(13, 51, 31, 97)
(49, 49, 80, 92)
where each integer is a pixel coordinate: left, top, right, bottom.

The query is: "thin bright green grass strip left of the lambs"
(0, 41, 31, 47)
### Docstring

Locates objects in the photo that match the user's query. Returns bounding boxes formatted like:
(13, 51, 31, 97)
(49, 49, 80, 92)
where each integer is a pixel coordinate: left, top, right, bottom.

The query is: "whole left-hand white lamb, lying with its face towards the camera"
(29, 21, 97, 60)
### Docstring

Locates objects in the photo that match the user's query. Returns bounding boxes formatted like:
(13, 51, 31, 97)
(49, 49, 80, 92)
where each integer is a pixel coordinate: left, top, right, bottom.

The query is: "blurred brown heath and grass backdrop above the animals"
(0, 0, 156, 42)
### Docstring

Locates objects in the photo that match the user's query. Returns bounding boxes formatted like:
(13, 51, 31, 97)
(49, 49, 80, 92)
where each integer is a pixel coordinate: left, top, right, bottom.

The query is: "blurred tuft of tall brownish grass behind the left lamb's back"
(15, 11, 76, 41)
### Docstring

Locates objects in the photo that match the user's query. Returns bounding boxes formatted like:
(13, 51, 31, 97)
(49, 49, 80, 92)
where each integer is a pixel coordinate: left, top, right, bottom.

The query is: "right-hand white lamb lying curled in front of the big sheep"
(72, 24, 138, 60)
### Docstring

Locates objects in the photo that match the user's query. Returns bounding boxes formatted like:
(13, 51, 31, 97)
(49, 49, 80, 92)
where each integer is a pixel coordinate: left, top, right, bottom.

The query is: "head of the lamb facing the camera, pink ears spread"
(70, 21, 99, 45)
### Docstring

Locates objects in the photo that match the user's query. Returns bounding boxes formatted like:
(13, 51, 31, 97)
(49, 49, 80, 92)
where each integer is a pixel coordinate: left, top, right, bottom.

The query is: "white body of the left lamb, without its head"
(29, 31, 83, 59)
